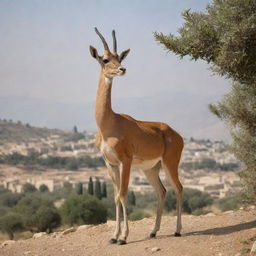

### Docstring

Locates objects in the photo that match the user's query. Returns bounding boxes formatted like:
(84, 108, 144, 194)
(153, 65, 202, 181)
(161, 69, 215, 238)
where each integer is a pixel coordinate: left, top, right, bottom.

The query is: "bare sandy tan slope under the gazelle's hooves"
(0, 207, 256, 256)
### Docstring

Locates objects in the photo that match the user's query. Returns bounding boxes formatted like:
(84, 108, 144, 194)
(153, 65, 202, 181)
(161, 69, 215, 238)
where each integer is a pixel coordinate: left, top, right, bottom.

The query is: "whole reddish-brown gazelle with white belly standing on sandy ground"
(90, 28, 183, 245)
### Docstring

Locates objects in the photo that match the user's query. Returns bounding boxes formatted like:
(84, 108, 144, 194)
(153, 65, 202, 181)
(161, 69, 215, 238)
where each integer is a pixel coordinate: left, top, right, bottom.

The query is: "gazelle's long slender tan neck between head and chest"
(95, 71, 114, 132)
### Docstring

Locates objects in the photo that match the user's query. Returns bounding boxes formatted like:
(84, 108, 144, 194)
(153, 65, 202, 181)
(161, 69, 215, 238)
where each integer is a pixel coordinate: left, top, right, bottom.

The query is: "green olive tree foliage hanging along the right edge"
(154, 0, 256, 203)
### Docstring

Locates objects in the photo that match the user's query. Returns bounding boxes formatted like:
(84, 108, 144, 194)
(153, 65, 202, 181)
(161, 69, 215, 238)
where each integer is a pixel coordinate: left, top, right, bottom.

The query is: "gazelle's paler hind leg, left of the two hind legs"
(143, 164, 166, 238)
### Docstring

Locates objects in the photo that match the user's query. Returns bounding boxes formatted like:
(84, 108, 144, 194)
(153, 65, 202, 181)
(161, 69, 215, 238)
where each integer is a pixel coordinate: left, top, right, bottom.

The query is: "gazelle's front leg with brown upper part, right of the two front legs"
(117, 159, 131, 245)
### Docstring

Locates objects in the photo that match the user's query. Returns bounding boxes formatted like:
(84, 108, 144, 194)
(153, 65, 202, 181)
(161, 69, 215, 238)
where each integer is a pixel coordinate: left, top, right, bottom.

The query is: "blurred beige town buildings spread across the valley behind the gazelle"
(0, 120, 242, 198)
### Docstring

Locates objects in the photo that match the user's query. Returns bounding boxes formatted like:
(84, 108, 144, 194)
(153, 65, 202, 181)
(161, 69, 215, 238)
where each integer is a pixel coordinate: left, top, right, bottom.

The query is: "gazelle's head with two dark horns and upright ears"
(90, 28, 130, 78)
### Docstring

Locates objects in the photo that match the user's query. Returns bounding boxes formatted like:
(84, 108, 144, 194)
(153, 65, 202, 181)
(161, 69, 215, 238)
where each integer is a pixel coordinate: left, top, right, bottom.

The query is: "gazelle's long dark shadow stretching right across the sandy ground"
(129, 220, 256, 244)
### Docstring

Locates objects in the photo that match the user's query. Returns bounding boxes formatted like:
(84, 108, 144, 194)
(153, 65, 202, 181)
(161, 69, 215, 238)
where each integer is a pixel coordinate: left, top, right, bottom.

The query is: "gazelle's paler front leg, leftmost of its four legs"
(107, 164, 121, 244)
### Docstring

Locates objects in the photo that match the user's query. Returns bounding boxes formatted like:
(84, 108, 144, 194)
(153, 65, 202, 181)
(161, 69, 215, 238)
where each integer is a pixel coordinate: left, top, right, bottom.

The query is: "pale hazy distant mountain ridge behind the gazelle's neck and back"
(0, 93, 229, 140)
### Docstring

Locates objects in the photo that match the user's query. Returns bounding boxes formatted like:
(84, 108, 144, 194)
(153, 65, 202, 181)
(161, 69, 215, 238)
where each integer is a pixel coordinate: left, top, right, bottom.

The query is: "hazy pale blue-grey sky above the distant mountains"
(0, 0, 229, 139)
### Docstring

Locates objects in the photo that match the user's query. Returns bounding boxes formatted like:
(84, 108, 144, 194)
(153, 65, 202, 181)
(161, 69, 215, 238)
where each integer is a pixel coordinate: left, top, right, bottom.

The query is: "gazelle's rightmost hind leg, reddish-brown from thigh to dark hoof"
(162, 137, 183, 236)
